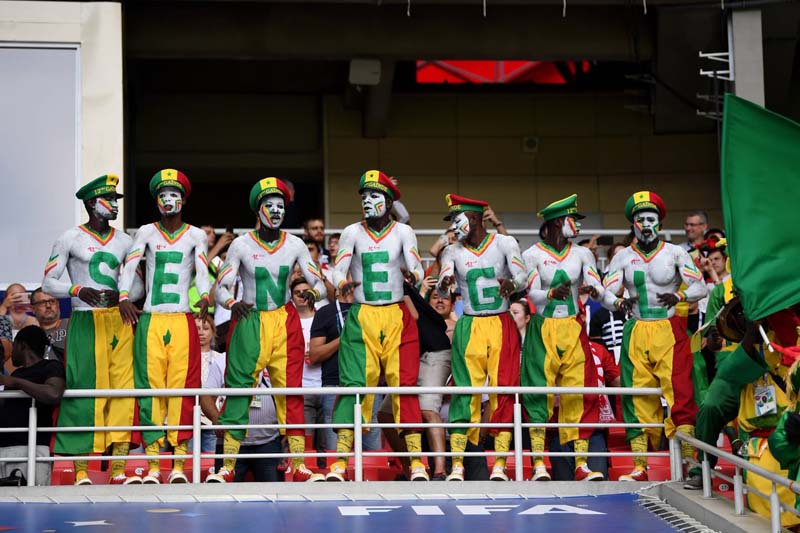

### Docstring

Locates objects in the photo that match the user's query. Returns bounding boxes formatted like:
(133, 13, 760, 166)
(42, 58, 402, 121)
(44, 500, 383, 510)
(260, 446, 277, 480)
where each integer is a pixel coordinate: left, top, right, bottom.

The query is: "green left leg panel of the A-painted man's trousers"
(520, 315, 550, 424)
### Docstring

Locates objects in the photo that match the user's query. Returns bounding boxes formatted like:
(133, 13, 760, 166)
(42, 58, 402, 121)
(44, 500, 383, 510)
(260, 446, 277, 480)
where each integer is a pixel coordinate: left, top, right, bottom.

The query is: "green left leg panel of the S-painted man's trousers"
(53, 311, 97, 454)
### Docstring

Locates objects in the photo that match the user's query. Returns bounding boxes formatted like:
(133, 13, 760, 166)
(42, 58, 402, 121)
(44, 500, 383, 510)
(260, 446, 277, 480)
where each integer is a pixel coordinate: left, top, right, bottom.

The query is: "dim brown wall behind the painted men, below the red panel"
(325, 93, 722, 248)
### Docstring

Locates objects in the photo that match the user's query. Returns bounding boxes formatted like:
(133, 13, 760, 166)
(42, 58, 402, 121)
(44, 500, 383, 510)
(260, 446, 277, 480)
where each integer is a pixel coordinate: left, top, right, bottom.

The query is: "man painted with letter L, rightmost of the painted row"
(603, 191, 706, 481)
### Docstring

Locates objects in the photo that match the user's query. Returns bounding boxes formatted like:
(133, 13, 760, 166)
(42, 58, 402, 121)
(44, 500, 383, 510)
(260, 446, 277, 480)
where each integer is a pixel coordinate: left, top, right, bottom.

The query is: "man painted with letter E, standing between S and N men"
(119, 169, 211, 484)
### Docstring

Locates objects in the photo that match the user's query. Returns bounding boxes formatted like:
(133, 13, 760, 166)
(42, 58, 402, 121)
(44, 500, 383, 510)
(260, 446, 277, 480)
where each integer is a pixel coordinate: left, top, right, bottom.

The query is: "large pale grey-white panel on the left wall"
(0, 47, 80, 288)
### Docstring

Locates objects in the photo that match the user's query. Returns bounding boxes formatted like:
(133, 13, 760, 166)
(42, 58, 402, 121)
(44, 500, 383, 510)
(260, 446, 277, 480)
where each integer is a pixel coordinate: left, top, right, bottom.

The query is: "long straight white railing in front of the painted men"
(0, 387, 668, 486)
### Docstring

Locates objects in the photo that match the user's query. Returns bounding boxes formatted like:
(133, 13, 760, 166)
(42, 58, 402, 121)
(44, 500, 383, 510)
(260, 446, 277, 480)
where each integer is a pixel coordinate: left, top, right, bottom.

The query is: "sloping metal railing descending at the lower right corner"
(675, 431, 800, 533)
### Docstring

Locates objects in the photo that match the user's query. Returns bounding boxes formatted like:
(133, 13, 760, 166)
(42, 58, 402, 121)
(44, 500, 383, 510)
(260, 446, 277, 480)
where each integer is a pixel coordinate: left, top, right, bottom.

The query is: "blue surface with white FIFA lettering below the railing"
(0, 494, 675, 533)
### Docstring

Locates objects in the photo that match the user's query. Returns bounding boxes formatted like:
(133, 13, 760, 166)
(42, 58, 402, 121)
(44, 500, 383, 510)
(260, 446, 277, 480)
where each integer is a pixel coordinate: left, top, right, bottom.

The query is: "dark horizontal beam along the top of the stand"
(124, 3, 654, 61)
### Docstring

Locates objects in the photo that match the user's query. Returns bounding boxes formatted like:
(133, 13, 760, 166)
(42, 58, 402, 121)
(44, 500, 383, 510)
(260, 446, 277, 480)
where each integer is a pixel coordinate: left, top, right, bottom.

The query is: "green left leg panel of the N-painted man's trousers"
(218, 309, 262, 441)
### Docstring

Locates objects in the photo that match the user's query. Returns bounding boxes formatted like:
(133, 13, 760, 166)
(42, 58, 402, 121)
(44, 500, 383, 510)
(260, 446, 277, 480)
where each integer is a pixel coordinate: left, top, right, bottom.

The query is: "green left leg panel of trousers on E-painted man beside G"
(333, 304, 367, 424)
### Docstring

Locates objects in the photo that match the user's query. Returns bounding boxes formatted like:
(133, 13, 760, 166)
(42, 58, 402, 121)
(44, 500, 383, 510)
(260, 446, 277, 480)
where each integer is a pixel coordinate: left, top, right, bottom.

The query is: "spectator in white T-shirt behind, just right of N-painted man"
(289, 276, 325, 466)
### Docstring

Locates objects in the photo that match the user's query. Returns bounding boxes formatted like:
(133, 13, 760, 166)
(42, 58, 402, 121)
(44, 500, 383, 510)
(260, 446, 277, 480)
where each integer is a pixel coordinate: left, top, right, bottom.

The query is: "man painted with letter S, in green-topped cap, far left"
(42, 174, 143, 485)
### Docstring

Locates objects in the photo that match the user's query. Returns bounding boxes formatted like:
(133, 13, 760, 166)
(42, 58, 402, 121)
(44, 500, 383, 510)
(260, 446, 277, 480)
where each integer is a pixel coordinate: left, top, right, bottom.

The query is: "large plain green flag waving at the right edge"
(721, 94, 800, 320)
